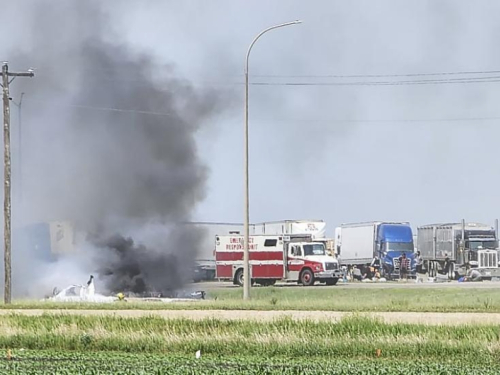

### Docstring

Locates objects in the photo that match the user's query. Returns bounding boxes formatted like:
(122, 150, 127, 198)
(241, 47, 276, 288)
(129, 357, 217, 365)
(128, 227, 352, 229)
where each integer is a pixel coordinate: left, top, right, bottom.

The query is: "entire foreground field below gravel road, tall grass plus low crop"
(0, 315, 500, 374)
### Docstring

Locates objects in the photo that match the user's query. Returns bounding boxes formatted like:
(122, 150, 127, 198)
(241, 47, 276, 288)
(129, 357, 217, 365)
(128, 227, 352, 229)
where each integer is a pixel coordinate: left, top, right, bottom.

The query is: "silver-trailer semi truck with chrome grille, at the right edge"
(417, 220, 500, 279)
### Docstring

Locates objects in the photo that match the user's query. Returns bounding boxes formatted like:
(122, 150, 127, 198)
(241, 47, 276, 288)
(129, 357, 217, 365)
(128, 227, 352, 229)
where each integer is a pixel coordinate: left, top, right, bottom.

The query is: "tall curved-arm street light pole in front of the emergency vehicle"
(243, 21, 302, 300)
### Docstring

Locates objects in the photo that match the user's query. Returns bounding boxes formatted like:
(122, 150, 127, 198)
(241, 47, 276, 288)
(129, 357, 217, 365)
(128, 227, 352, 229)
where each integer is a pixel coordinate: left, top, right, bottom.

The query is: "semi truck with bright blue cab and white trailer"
(335, 221, 416, 279)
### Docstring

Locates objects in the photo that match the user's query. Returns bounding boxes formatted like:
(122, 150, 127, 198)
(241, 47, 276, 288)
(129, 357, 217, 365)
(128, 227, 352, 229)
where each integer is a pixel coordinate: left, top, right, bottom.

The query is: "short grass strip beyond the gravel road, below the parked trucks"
(5, 285, 500, 312)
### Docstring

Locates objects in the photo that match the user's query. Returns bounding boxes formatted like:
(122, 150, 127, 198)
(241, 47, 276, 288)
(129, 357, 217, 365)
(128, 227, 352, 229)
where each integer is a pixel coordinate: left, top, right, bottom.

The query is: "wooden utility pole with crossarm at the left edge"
(2, 62, 35, 304)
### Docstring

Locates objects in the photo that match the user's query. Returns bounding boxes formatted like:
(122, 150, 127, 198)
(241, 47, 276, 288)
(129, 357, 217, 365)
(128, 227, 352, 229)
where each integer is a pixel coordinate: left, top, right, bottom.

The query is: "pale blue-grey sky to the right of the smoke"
(0, 0, 500, 235)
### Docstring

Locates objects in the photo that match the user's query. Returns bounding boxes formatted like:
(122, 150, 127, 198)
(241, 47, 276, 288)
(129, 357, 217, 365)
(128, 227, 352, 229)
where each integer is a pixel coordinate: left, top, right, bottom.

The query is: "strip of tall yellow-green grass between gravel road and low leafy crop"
(0, 315, 500, 361)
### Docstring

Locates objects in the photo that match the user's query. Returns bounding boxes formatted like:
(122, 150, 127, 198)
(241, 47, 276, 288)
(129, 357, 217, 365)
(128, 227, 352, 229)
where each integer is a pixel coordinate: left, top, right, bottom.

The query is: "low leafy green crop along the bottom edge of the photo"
(0, 350, 500, 375)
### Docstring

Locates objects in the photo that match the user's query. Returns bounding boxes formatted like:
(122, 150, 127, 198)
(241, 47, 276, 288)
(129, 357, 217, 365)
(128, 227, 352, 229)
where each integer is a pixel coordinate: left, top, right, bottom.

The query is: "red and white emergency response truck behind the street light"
(215, 235, 341, 286)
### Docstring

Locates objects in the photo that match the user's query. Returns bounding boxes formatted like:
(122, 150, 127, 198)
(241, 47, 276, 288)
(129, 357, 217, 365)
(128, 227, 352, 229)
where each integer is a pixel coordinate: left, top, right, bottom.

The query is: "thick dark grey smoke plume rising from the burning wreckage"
(3, 1, 220, 298)
